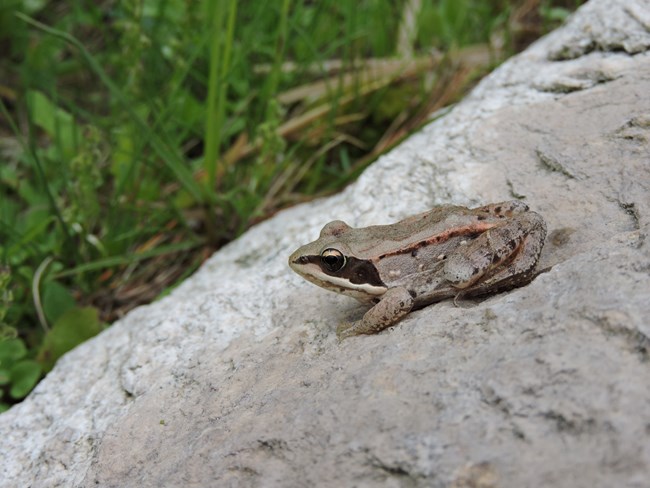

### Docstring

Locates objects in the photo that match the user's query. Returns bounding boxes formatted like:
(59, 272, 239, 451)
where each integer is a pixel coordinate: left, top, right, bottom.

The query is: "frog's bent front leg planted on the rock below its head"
(336, 287, 413, 340)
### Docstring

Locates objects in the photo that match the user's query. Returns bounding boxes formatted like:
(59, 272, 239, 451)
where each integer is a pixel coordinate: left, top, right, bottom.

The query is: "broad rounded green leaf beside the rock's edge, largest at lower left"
(36, 307, 102, 372)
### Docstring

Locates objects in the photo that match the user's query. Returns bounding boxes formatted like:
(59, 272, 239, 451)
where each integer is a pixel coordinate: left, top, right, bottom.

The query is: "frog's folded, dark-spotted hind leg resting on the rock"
(444, 212, 546, 292)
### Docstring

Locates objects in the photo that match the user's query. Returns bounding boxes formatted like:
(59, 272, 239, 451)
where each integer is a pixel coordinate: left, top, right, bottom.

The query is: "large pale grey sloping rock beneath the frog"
(0, 0, 650, 488)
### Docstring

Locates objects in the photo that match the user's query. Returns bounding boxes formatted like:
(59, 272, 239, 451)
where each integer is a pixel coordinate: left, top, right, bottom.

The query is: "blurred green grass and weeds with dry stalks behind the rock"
(0, 0, 580, 410)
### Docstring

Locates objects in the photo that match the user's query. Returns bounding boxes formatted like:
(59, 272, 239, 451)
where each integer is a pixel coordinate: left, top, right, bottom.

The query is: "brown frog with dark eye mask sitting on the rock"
(289, 200, 546, 340)
